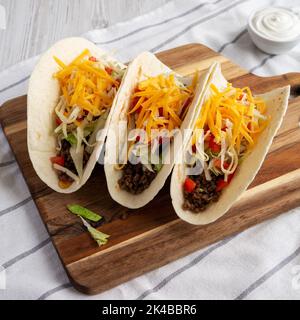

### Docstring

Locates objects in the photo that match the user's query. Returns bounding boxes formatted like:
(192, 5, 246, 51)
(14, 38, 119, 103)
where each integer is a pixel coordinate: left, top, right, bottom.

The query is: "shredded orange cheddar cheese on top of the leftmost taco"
(54, 49, 119, 119)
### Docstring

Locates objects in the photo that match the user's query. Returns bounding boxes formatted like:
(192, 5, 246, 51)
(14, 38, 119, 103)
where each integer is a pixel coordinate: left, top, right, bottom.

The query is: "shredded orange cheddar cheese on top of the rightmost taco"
(192, 84, 269, 154)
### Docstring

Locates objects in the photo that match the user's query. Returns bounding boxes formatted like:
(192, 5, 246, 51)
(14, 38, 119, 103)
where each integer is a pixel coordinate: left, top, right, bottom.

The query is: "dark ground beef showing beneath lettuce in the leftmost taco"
(58, 139, 90, 182)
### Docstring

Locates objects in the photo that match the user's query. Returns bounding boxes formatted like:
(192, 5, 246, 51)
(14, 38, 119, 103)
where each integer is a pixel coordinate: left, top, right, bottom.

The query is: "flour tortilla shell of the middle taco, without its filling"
(104, 52, 215, 209)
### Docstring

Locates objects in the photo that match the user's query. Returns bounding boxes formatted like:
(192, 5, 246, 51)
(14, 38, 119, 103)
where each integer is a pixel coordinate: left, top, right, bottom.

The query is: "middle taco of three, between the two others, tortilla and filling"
(104, 52, 217, 208)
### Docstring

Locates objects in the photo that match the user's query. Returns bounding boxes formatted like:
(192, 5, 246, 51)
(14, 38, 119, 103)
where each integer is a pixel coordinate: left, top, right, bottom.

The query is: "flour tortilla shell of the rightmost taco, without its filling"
(171, 65, 290, 225)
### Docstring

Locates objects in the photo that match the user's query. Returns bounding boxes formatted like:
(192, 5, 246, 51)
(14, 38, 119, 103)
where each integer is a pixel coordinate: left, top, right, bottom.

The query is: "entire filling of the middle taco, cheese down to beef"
(116, 73, 198, 194)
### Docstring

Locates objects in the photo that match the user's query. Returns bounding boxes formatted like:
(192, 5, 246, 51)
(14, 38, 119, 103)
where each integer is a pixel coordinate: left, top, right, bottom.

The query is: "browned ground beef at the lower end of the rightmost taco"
(183, 173, 221, 213)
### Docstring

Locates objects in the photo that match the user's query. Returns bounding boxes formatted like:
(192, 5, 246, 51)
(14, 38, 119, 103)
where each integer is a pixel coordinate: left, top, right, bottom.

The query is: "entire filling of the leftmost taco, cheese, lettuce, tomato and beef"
(50, 49, 124, 188)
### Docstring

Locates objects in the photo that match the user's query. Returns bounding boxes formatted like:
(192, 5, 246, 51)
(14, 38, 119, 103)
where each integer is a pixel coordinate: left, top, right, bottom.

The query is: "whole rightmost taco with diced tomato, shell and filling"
(171, 64, 290, 224)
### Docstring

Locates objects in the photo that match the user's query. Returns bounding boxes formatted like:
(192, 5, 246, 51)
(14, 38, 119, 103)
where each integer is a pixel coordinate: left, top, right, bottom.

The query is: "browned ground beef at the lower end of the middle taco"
(118, 163, 156, 194)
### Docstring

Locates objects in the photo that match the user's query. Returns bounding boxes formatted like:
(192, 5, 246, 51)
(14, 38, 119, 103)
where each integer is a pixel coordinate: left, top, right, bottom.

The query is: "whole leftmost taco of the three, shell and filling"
(27, 38, 125, 193)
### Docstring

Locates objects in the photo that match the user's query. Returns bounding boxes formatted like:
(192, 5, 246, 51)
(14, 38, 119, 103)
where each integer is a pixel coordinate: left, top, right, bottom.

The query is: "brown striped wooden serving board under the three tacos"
(0, 44, 300, 294)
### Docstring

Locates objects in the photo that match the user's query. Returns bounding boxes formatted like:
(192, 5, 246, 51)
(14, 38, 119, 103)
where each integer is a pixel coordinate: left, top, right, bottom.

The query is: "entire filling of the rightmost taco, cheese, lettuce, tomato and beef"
(183, 83, 270, 212)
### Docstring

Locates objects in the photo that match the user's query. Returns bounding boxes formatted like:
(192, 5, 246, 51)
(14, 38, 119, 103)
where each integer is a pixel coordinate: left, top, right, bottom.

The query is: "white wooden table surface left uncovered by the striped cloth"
(0, 0, 169, 71)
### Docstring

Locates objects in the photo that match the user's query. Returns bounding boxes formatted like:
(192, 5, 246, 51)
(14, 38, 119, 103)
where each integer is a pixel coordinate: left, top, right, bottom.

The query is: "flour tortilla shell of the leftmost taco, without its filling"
(27, 38, 125, 193)
